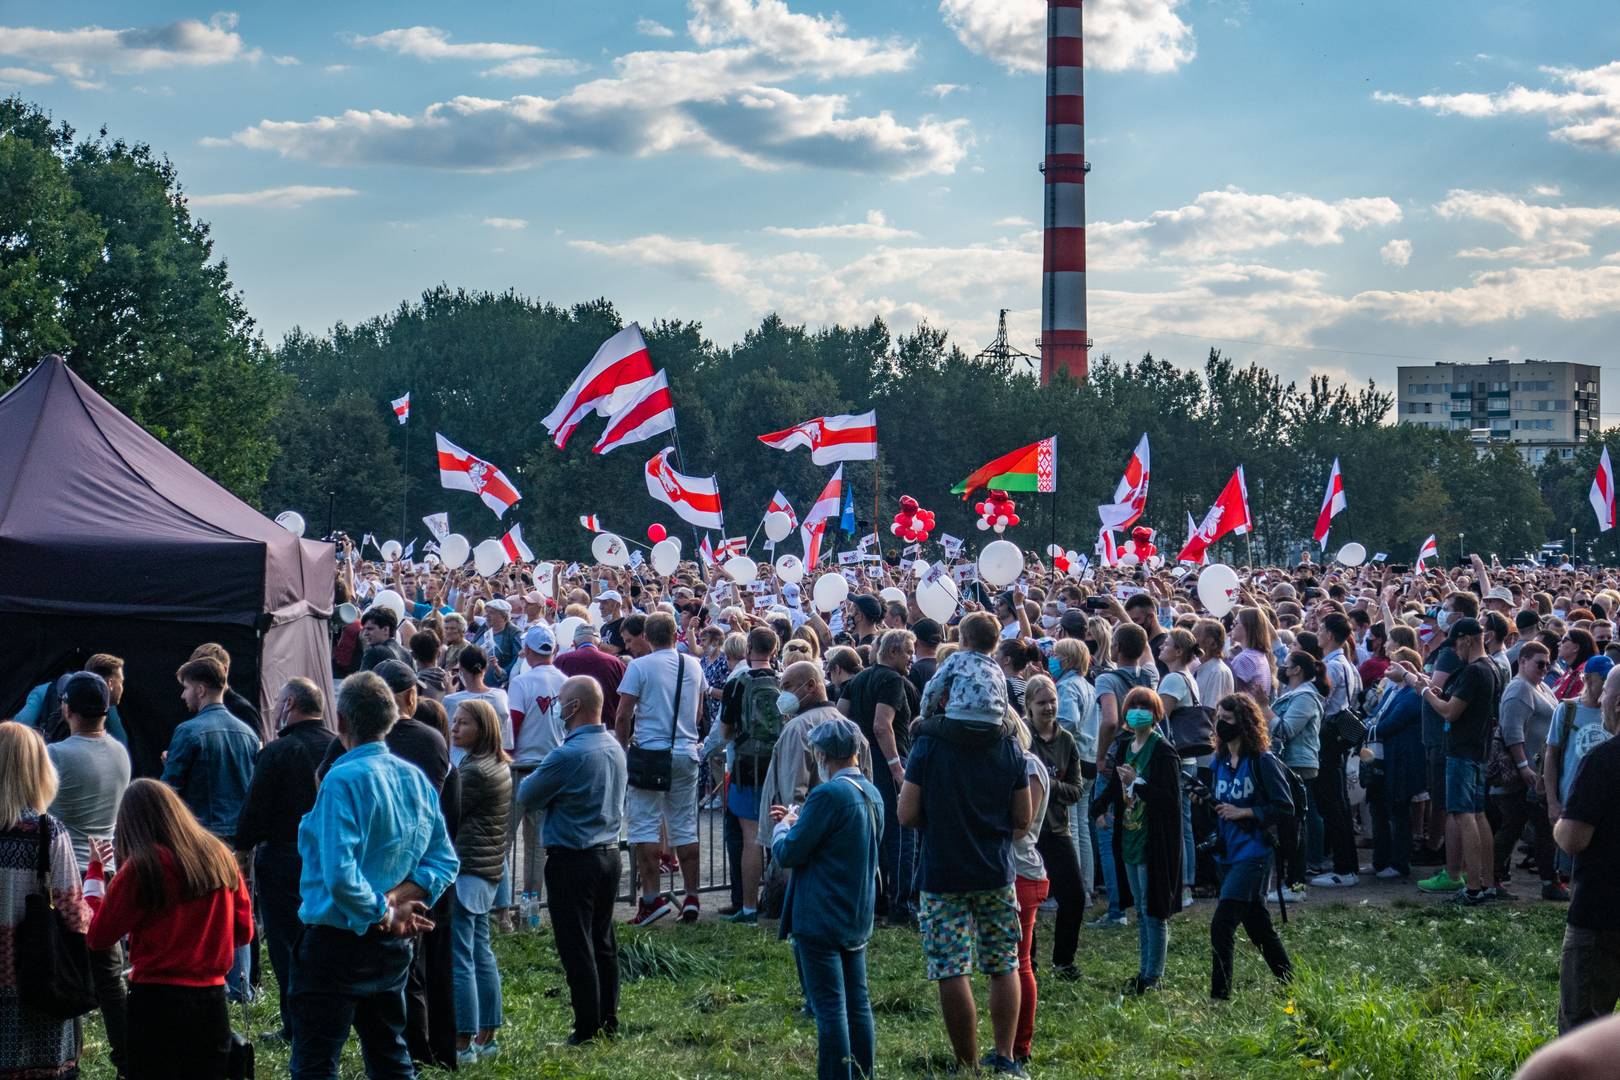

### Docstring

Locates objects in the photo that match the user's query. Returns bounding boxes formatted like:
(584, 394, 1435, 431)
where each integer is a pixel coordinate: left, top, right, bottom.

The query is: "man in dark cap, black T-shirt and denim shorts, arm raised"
(1405, 619, 1502, 904)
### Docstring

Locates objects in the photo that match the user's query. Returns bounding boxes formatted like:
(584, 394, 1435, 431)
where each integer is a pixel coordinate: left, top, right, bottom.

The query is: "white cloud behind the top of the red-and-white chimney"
(940, 0, 1197, 71)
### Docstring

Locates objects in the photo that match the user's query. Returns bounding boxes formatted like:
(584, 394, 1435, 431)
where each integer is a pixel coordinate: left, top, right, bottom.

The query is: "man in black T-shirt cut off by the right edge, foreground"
(1552, 738, 1620, 1035)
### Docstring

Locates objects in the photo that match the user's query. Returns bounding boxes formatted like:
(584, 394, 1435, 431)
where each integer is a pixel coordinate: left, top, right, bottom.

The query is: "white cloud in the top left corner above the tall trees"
(0, 13, 261, 81)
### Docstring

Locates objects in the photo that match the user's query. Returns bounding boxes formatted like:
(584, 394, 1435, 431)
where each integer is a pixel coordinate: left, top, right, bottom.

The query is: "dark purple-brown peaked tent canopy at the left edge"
(0, 356, 335, 772)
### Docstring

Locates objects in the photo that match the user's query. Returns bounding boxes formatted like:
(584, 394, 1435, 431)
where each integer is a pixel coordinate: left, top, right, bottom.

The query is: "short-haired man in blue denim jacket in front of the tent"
(164, 656, 259, 844)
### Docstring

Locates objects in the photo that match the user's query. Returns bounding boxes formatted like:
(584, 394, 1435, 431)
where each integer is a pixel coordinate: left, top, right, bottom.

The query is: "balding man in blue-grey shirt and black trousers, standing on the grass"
(517, 675, 625, 1046)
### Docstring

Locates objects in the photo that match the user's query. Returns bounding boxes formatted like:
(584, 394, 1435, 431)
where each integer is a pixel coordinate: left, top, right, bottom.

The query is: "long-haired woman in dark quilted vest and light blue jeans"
(450, 699, 512, 1065)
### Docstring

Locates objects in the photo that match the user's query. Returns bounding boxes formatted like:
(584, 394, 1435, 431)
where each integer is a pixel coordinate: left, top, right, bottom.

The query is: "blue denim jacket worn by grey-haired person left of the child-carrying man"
(771, 769, 883, 949)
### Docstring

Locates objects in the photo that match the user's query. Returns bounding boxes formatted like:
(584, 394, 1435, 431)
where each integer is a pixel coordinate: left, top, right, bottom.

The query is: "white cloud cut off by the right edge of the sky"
(1372, 60, 1620, 152)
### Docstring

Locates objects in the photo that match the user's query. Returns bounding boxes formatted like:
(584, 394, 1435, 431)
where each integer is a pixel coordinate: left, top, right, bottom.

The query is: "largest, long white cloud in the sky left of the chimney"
(221, 0, 969, 178)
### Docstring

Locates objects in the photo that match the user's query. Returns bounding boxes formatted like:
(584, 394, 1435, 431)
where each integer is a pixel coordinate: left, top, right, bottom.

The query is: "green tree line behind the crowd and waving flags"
(0, 97, 1594, 562)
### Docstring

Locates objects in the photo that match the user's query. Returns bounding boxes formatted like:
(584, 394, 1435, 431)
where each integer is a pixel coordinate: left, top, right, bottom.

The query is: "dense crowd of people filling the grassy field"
(0, 544, 1620, 1080)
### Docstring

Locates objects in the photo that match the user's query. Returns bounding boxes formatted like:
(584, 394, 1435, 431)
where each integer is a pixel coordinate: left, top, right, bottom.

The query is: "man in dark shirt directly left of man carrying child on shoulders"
(838, 630, 917, 923)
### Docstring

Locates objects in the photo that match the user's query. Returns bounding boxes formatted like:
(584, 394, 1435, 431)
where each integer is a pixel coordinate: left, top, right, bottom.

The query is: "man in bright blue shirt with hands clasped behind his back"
(290, 672, 460, 1080)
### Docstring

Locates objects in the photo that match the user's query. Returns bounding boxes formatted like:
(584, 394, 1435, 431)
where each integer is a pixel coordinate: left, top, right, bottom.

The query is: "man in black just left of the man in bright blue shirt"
(233, 678, 337, 1041)
